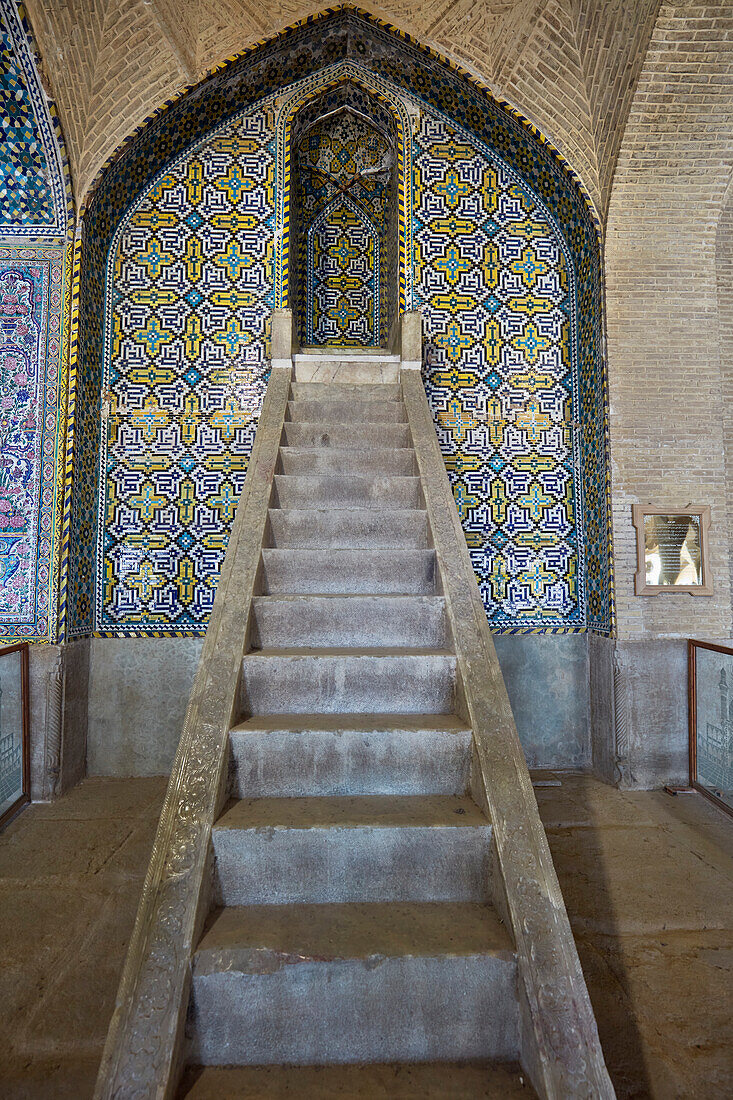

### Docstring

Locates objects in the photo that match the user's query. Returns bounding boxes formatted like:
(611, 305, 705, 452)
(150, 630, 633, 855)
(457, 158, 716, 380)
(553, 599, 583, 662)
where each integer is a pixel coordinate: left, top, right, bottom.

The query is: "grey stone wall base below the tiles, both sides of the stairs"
(75, 634, 717, 798)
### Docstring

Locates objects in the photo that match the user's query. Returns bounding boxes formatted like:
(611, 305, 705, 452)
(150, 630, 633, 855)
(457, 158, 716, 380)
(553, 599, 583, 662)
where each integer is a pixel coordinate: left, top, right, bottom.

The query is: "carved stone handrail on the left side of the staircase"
(95, 356, 292, 1100)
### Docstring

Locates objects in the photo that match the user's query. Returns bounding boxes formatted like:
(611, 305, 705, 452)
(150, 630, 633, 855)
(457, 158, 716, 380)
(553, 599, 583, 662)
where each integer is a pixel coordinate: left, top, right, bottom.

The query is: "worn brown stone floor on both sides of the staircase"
(0, 776, 733, 1100)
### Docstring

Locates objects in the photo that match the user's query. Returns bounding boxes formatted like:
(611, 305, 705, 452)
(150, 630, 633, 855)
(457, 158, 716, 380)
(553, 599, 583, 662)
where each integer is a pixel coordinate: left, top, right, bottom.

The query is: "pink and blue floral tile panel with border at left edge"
(0, 246, 66, 644)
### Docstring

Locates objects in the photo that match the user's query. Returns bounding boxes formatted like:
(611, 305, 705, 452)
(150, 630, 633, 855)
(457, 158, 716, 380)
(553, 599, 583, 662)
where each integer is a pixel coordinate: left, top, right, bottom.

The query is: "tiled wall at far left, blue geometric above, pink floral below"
(0, 0, 70, 644)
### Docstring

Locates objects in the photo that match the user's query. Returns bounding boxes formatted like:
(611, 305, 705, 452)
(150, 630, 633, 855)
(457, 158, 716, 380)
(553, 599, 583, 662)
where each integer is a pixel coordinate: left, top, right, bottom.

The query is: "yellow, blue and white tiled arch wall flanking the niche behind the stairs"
(69, 13, 611, 634)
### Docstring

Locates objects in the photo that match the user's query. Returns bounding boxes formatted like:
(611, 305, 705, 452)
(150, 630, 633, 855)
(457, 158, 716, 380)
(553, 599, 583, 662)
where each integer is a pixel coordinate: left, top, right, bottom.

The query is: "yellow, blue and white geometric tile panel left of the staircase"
(97, 110, 274, 634)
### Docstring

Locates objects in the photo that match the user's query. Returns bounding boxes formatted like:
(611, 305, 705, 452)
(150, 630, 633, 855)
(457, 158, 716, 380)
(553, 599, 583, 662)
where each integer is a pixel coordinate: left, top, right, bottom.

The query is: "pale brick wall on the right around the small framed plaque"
(606, 2, 733, 639)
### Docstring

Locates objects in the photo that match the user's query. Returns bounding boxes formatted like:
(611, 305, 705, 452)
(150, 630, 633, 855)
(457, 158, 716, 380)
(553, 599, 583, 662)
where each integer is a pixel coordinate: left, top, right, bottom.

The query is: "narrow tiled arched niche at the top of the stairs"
(287, 79, 405, 347)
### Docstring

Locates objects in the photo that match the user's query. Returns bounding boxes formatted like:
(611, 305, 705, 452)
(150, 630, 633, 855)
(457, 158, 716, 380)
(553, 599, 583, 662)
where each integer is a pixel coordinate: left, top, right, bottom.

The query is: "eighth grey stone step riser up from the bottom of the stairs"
(272, 474, 423, 509)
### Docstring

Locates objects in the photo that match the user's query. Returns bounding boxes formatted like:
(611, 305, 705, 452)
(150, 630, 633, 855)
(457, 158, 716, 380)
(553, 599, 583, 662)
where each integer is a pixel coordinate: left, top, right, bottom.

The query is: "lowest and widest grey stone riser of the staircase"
(190, 956, 518, 1065)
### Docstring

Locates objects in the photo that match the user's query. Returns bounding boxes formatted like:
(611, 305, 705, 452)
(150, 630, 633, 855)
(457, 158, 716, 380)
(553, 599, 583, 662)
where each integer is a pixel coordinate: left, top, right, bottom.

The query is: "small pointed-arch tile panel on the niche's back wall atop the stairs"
(306, 197, 380, 347)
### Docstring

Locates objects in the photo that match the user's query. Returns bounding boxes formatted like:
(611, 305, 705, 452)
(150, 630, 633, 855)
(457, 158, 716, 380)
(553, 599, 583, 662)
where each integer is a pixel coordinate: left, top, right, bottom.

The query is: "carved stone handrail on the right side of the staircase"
(402, 327, 615, 1100)
